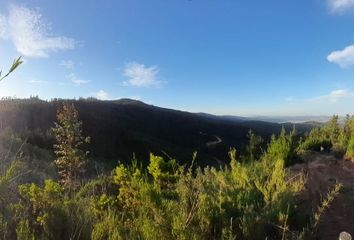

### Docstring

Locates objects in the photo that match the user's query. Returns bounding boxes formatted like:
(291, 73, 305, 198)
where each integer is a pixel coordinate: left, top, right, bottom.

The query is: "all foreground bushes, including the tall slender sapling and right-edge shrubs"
(0, 105, 348, 240)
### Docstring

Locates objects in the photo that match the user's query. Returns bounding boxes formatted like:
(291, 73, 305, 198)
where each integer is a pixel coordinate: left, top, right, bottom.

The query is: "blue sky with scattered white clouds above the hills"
(0, 0, 354, 116)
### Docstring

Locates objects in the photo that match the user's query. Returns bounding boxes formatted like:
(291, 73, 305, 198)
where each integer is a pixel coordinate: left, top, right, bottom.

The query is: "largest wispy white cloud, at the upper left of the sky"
(0, 5, 76, 58)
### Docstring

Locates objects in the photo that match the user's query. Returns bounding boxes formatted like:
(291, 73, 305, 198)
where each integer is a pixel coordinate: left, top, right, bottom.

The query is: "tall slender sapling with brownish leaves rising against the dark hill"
(52, 103, 90, 192)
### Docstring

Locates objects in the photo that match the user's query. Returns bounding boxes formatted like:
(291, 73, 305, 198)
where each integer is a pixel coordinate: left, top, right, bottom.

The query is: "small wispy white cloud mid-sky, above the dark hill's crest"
(124, 62, 162, 87)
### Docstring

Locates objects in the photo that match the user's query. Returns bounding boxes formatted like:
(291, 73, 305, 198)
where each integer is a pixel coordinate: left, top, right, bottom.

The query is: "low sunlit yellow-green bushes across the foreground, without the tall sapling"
(0, 154, 304, 239)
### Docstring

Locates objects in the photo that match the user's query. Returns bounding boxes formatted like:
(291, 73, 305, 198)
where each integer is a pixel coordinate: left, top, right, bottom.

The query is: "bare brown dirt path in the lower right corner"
(294, 155, 354, 240)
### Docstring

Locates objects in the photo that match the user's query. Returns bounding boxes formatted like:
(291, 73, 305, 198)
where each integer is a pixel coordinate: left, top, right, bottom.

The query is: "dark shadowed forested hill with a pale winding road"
(0, 98, 312, 165)
